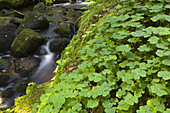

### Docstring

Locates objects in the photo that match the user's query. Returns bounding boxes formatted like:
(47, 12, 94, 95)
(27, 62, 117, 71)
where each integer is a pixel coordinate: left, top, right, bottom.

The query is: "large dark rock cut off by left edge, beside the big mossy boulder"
(0, 17, 18, 53)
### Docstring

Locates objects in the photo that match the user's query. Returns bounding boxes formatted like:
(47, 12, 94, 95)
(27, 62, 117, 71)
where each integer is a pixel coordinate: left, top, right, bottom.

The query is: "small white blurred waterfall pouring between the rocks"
(31, 40, 55, 84)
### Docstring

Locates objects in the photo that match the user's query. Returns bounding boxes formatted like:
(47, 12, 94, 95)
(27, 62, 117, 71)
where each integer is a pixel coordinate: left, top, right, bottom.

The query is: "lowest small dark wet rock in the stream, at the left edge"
(0, 88, 15, 98)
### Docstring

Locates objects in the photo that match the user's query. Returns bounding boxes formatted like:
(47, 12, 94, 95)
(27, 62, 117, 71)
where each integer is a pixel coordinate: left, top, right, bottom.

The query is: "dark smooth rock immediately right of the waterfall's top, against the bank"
(50, 38, 70, 53)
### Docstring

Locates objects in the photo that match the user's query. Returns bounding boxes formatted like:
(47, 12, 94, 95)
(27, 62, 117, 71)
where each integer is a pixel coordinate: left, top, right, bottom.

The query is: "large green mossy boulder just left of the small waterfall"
(11, 29, 44, 56)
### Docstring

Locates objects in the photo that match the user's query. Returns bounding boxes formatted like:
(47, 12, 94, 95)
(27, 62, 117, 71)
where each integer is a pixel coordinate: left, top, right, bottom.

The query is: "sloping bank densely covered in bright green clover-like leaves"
(32, 0, 170, 113)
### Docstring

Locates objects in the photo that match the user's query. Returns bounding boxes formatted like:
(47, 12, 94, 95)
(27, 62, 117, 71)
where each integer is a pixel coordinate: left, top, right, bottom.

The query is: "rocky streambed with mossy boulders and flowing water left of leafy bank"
(0, 3, 88, 109)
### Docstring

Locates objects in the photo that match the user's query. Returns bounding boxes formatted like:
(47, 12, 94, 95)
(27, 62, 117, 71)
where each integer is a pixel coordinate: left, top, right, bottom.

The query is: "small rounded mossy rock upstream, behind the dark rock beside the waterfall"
(54, 22, 71, 38)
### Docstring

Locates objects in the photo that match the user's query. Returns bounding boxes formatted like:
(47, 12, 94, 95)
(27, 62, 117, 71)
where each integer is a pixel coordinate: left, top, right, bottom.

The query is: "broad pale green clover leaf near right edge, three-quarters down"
(151, 84, 168, 96)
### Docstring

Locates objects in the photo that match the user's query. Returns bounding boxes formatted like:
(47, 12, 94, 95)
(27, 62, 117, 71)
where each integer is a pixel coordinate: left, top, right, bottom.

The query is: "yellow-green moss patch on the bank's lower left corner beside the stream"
(11, 83, 50, 113)
